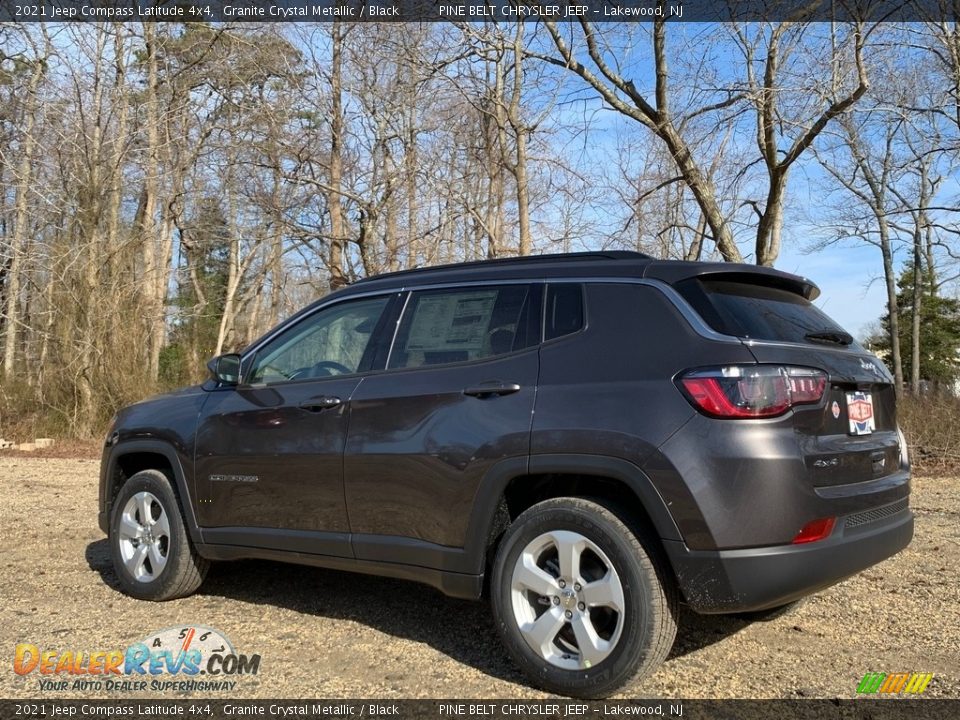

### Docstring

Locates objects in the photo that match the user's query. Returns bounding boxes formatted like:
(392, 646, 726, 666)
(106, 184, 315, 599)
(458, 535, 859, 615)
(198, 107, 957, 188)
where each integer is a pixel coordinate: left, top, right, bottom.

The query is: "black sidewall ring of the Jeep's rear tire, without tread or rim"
(491, 503, 657, 697)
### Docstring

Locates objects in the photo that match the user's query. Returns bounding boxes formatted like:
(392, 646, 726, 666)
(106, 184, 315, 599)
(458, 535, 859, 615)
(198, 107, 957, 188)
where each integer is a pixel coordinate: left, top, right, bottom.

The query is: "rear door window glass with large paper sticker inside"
(389, 285, 539, 368)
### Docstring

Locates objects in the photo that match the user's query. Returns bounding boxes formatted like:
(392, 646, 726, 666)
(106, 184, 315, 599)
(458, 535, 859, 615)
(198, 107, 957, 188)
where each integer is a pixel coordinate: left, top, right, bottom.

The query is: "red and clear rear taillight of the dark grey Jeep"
(677, 365, 827, 418)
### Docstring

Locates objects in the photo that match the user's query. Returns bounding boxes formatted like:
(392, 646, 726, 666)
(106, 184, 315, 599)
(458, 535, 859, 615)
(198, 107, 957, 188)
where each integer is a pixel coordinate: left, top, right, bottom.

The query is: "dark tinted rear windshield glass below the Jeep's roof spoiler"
(681, 280, 846, 343)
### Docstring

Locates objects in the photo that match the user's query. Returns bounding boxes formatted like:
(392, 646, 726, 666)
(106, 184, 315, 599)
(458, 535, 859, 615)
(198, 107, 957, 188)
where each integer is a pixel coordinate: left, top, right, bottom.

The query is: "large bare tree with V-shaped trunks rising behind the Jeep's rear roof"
(535, 18, 875, 265)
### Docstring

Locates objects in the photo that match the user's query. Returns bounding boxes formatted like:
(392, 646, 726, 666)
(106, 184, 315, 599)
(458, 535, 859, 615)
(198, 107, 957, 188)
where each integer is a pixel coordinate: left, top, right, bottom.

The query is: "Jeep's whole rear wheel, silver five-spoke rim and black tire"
(491, 498, 677, 698)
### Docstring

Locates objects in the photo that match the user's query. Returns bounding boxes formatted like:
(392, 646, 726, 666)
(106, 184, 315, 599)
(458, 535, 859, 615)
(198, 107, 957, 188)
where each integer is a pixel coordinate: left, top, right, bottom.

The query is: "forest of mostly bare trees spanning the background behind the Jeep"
(0, 21, 960, 437)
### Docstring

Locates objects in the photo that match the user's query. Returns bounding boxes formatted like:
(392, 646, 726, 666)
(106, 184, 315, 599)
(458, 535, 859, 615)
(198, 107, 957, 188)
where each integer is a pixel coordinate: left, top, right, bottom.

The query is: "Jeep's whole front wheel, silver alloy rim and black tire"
(110, 470, 209, 600)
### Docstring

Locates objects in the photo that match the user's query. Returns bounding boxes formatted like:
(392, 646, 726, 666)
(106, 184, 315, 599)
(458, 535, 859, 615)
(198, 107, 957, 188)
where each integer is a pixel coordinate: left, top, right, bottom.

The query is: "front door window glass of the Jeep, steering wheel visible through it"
(247, 297, 389, 385)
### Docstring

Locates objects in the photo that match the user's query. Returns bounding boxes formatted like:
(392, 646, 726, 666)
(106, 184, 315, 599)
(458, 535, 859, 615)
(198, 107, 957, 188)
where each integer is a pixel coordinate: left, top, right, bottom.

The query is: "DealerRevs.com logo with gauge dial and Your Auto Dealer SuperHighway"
(13, 625, 260, 693)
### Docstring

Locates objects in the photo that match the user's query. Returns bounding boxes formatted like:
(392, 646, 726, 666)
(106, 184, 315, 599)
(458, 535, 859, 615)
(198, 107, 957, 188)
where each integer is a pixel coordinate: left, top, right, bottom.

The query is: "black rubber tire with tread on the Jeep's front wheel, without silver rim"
(109, 470, 210, 601)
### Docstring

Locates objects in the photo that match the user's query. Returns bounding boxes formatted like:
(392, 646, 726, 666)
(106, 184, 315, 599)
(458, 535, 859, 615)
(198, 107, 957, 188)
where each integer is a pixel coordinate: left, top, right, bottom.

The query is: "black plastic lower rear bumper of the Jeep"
(663, 509, 913, 613)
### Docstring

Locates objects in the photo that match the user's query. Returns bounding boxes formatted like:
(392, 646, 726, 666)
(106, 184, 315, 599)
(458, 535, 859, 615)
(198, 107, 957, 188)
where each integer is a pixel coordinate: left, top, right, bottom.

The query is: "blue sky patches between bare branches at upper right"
(524, 23, 960, 339)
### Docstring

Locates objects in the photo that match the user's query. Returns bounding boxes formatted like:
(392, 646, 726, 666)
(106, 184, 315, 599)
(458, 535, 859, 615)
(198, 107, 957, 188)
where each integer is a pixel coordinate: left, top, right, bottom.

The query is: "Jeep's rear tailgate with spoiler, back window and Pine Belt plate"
(675, 269, 900, 486)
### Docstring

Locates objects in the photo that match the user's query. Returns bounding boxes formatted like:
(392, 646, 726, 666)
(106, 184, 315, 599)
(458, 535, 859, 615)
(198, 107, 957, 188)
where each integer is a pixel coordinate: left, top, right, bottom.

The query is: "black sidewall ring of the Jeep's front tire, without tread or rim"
(109, 470, 185, 600)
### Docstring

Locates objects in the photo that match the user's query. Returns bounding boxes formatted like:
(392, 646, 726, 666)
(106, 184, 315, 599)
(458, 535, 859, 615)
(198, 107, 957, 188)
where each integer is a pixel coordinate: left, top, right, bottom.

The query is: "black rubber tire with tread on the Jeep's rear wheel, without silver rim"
(490, 497, 678, 698)
